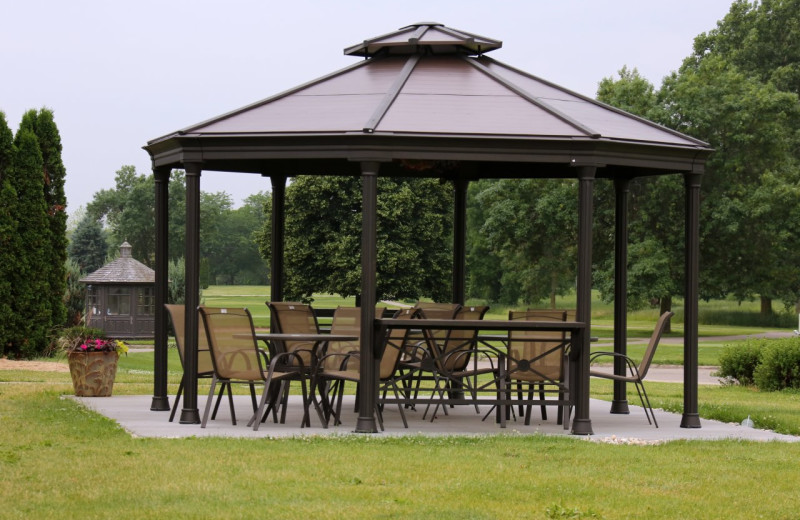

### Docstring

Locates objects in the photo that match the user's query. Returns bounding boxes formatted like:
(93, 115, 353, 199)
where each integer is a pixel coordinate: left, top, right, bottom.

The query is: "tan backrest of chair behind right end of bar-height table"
(508, 309, 567, 381)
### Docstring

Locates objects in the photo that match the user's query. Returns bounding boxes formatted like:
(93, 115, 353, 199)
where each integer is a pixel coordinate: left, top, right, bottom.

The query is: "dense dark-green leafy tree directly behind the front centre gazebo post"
(258, 176, 453, 301)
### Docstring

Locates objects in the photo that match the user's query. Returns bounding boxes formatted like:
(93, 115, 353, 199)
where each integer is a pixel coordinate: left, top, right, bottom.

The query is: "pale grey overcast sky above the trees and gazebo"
(0, 0, 732, 212)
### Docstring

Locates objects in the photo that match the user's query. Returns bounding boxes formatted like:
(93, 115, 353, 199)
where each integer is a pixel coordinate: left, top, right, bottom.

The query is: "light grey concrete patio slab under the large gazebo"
(72, 396, 800, 444)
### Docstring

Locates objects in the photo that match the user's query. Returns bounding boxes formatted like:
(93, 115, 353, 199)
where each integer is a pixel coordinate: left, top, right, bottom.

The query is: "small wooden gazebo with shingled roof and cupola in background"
(80, 242, 155, 338)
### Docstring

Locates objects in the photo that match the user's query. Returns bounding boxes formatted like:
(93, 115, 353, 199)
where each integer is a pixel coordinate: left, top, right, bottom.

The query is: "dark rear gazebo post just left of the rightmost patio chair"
(611, 178, 630, 414)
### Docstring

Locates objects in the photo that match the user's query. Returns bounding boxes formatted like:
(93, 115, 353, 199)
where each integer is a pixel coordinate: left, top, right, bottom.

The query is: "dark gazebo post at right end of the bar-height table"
(570, 166, 597, 435)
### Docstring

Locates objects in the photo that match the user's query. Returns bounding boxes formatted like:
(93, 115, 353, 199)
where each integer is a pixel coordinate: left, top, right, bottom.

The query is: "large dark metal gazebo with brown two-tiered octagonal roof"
(145, 22, 712, 434)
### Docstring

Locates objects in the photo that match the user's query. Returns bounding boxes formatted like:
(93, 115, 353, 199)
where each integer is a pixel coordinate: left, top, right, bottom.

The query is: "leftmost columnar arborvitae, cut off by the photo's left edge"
(0, 112, 17, 352)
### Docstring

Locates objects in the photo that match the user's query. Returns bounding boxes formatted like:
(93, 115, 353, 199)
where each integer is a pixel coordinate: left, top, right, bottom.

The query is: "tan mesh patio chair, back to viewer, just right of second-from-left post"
(200, 306, 308, 430)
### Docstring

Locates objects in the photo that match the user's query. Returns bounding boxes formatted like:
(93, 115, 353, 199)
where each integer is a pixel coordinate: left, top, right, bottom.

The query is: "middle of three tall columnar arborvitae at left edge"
(11, 128, 51, 357)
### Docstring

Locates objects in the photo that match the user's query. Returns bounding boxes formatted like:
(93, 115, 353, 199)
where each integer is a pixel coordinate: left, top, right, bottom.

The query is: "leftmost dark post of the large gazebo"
(150, 167, 171, 412)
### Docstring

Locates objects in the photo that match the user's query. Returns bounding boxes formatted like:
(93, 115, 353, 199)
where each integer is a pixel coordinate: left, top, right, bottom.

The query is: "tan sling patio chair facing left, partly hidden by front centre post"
(314, 307, 418, 430)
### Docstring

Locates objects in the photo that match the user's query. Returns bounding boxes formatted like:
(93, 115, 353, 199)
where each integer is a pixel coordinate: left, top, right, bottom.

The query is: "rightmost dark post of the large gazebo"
(681, 172, 702, 428)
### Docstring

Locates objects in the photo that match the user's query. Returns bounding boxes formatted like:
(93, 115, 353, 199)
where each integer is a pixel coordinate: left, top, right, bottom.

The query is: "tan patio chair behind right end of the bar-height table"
(507, 309, 567, 425)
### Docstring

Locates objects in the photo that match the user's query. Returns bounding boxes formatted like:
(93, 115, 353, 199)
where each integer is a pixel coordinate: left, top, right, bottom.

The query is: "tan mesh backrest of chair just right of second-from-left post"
(200, 306, 264, 381)
